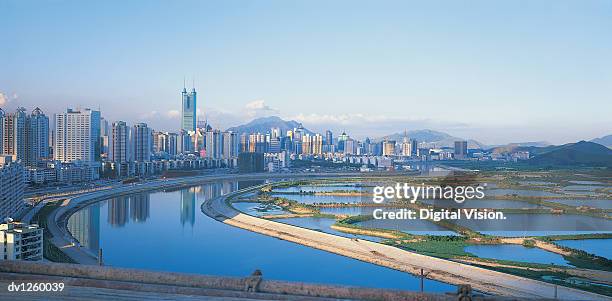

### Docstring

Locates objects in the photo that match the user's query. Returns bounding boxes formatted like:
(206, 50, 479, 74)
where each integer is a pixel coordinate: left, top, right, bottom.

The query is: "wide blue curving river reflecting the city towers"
(69, 182, 455, 291)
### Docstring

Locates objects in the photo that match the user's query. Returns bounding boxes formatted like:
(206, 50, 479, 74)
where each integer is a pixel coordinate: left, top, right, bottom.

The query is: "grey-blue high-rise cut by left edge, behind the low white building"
(0, 155, 25, 220)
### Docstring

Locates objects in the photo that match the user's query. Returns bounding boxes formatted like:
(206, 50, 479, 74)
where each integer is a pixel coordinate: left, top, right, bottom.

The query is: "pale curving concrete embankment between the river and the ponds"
(202, 186, 611, 300)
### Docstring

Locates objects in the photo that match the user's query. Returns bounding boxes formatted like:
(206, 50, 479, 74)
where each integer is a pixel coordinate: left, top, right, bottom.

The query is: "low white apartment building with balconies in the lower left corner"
(0, 219, 43, 261)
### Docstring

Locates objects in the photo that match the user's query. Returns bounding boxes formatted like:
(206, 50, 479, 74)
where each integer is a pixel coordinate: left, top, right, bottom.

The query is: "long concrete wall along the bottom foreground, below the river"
(0, 261, 470, 301)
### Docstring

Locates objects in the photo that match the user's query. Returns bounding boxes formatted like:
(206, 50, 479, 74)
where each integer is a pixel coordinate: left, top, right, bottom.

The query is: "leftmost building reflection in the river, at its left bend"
(68, 203, 100, 254)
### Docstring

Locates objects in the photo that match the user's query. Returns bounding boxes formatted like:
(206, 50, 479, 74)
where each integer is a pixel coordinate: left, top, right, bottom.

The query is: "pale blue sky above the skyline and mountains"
(0, 0, 612, 144)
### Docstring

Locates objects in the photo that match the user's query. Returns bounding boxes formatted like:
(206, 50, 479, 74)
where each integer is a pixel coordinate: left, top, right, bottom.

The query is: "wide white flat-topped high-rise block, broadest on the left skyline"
(53, 109, 101, 164)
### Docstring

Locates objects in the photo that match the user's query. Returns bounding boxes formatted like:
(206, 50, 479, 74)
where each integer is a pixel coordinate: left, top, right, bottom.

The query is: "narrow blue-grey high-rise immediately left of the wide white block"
(25, 108, 49, 166)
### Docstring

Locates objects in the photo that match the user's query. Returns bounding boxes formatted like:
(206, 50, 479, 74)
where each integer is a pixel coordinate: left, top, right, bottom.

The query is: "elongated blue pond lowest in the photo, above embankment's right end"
(464, 245, 569, 265)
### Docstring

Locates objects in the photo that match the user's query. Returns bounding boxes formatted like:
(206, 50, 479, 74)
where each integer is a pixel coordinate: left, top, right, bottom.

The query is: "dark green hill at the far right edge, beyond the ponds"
(528, 141, 612, 167)
